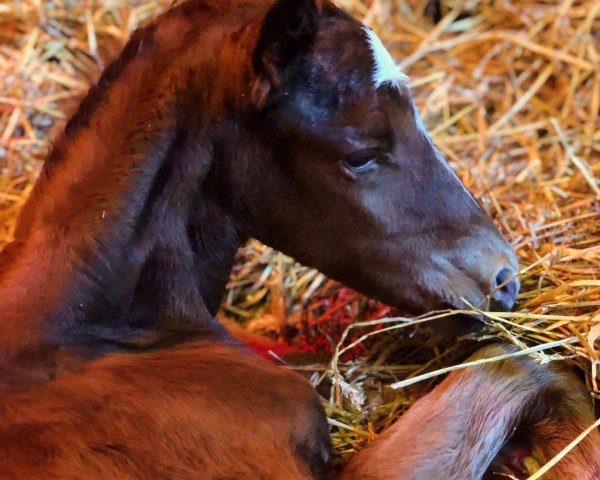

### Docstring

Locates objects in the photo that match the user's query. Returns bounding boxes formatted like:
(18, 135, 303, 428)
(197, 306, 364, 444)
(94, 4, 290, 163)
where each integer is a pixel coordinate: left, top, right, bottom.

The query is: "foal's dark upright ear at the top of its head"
(252, 0, 322, 87)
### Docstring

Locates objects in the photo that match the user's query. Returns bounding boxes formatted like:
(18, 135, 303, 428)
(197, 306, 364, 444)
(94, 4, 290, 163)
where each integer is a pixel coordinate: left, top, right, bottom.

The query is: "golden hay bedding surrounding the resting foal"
(0, 0, 600, 472)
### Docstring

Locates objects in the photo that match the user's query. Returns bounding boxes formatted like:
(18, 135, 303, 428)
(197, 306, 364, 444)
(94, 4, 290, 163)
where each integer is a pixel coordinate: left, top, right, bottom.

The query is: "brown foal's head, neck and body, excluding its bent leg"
(0, 0, 596, 480)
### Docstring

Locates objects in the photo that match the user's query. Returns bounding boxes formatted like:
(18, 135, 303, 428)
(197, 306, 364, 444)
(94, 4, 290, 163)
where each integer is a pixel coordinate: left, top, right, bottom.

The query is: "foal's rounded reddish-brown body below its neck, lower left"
(0, 342, 329, 480)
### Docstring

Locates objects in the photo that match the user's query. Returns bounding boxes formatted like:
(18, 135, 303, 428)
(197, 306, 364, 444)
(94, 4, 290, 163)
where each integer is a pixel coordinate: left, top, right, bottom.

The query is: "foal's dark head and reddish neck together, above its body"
(0, 0, 518, 389)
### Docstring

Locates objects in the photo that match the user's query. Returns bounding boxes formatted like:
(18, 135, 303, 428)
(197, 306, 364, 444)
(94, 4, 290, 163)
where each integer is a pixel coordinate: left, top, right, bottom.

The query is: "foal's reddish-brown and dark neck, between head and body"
(0, 5, 250, 369)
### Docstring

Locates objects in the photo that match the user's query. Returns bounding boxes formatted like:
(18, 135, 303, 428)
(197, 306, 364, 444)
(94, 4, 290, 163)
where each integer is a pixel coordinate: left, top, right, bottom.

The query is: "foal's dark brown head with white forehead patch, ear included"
(227, 0, 518, 312)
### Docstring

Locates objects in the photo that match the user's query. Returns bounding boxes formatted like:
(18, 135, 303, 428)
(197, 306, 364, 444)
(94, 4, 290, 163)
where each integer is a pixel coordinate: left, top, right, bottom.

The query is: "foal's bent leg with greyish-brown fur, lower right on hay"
(338, 345, 600, 480)
